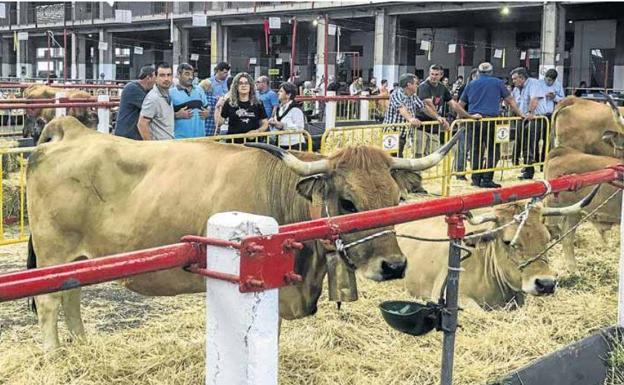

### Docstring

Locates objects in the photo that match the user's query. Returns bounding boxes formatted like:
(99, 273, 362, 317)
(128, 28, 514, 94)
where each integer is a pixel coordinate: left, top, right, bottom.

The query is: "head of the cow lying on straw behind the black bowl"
(466, 202, 557, 295)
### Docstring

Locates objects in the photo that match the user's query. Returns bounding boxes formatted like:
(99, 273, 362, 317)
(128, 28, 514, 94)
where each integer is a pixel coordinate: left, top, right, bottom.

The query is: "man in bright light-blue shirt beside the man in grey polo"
(169, 63, 211, 139)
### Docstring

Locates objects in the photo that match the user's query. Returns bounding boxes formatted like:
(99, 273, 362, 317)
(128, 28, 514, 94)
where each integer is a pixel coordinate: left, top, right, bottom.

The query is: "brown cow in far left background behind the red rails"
(22, 84, 98, 144)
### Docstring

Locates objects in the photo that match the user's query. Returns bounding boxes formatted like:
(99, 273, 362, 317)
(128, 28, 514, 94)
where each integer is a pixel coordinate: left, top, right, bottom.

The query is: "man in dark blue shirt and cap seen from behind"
(453, 62, 524, 188)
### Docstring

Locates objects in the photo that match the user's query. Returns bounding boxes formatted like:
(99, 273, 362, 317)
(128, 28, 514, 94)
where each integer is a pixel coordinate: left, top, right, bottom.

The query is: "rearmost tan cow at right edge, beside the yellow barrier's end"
(552, 96, 624, 157)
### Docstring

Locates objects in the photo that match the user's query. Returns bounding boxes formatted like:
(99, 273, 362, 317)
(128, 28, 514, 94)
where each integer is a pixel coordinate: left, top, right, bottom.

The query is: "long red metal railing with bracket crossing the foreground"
(0, 165, 624, 302)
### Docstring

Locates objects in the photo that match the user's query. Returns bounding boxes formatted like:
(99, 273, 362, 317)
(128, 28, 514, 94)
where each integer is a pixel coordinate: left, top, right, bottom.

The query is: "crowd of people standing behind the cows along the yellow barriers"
(114, 62, 564, 188)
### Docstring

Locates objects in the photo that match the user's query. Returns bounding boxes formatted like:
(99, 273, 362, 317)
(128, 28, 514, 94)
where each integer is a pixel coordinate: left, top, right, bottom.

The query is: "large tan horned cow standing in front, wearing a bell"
(27, 117, 464, 349)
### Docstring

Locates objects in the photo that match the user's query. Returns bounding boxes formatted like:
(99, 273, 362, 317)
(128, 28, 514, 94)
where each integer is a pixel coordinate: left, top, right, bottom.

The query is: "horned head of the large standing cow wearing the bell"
(249, 129, 458, 281)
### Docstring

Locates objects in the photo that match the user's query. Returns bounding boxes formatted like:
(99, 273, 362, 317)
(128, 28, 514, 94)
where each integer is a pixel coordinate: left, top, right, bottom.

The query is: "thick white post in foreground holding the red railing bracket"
(206, 212, 279, 385)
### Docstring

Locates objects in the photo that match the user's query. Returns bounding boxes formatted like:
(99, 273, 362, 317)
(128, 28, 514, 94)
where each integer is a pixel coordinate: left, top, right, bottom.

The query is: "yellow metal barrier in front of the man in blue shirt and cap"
(444, 116, 551, 195)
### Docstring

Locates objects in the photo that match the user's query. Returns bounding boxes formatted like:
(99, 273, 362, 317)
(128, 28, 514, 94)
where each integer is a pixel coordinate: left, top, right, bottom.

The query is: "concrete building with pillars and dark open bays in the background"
(0, 1, 624, 89)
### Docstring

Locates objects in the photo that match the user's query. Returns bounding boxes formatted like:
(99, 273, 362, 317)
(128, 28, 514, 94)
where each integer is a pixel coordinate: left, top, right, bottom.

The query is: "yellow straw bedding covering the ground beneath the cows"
(0, 172, 624, 385)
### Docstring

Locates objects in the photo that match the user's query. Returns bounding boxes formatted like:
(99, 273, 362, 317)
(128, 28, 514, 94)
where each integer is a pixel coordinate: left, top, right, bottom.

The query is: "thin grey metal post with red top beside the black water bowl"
(440, 214, 466, 385)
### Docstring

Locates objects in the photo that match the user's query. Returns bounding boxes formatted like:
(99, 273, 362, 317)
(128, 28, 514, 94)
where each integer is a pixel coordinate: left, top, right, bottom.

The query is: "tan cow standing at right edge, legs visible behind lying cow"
(544, 147, 622, 273)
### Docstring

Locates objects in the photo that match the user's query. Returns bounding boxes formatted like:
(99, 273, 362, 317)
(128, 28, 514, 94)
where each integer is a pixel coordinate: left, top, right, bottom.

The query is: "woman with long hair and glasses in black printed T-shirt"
(217, 72, 269, 143)
